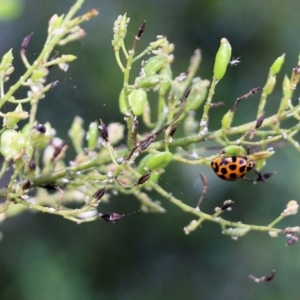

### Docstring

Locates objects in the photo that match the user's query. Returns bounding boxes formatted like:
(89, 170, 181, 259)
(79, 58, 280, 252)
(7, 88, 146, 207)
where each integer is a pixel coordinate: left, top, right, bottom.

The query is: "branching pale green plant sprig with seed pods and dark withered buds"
(0, 0, 300, 241)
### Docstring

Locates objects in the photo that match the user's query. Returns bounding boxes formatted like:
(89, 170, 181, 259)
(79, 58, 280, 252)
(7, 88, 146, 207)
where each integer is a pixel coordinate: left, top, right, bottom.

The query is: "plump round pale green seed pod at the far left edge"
(0, 129, 25, 160)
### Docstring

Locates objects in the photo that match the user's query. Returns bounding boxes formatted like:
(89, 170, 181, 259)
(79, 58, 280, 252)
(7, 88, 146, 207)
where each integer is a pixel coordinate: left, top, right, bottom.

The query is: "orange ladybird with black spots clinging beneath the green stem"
(211, 156, 254, 180)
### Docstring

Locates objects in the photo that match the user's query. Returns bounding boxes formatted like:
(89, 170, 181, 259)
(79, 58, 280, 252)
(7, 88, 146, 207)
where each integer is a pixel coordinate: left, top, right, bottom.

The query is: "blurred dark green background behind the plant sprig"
(0, 0, 300, 300)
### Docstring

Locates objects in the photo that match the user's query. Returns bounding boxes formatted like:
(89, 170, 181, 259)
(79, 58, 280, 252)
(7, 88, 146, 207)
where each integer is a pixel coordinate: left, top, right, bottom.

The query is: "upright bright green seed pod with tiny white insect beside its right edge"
(214, 38, 231, 80)
